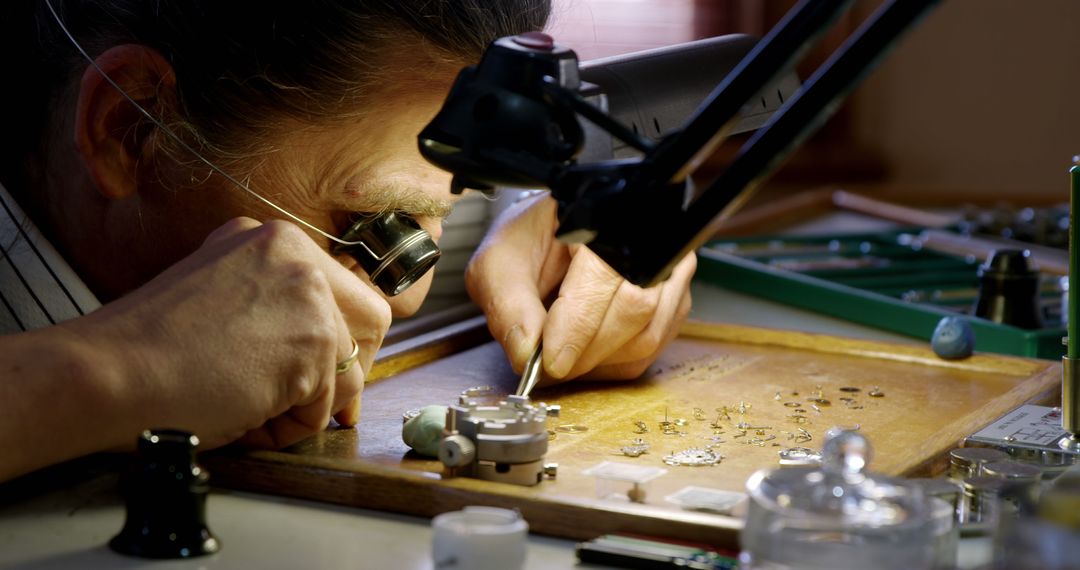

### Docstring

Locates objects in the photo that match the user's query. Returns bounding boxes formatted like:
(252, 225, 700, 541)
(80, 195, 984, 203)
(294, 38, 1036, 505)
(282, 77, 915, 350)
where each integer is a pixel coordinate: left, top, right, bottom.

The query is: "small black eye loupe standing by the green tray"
(975, 249, 1042, 329)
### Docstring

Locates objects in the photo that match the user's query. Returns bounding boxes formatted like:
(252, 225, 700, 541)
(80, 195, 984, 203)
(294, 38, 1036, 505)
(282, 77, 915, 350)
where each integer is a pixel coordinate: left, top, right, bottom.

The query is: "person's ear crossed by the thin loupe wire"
(75, 44, 176, 200)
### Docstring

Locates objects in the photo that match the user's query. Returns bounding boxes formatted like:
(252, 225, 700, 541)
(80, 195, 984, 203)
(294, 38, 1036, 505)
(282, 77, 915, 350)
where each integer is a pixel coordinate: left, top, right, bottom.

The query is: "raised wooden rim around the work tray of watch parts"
(201, 317, 1061, 549)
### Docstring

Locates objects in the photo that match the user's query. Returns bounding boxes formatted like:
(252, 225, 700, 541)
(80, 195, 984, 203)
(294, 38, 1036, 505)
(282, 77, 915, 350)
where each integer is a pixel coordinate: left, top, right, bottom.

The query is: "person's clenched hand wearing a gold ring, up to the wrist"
(73, 218, 390, 448)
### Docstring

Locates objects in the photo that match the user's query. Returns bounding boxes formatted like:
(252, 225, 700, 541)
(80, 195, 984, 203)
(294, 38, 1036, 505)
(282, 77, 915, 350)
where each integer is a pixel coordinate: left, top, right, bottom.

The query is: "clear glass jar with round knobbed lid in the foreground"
(740, 430, 942, 570)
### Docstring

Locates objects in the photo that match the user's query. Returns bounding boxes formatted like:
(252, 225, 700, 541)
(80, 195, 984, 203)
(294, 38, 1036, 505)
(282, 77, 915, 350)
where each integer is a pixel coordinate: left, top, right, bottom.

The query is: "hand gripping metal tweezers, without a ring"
(465, 198, 697, 380)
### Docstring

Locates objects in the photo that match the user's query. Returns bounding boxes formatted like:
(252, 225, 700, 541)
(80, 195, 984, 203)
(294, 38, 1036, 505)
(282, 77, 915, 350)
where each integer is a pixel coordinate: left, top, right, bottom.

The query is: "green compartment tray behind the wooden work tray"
(698, 229, 1066, 359)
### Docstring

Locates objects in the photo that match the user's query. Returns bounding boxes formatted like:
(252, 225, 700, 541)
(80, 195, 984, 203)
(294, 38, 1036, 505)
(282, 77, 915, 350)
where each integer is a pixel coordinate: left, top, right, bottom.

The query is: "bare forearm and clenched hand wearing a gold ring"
(0, 215, 390, 479)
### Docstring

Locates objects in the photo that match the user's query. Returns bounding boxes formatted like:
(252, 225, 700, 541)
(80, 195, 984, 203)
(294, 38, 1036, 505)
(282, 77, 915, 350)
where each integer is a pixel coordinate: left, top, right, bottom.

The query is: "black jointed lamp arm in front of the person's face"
(418, 0, 936, 286)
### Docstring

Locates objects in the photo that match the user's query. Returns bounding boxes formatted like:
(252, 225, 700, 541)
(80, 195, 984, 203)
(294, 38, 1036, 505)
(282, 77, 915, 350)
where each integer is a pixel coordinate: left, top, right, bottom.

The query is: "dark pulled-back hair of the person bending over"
(0, 0, 551, 178)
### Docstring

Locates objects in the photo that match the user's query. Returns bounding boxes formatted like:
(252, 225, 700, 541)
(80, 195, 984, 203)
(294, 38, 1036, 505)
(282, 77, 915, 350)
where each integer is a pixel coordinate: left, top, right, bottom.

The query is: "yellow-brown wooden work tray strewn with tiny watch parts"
(204, 324, 1061, 546)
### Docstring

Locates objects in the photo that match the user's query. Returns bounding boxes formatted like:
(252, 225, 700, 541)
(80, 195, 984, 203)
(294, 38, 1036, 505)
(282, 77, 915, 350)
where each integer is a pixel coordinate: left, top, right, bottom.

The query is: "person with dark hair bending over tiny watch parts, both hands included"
(0, 0, 694, 480)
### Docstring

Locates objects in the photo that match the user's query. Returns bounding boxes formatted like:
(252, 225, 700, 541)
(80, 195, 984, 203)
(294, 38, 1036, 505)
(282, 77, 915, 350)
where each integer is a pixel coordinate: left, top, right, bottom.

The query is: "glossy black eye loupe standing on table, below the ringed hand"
(109, 430, 221, 558)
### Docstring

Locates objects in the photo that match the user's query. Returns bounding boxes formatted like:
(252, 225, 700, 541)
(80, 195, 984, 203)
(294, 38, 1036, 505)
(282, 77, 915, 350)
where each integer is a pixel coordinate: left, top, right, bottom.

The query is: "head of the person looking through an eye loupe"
(2, 0, 550, 314)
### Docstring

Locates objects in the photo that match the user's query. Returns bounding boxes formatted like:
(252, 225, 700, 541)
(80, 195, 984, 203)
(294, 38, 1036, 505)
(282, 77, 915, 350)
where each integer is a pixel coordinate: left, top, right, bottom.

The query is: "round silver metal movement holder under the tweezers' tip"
(438, 395, 559, 486)
